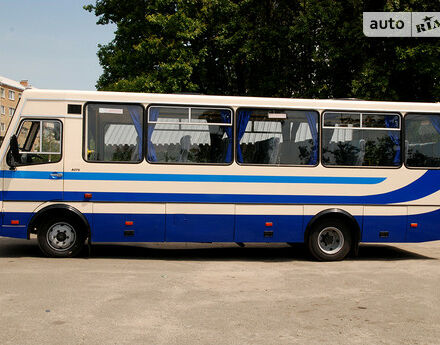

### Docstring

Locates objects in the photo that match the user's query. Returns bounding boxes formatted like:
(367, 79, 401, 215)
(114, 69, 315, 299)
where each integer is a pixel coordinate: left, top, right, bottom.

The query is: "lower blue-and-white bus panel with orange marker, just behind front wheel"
(92, 203, 165, 242)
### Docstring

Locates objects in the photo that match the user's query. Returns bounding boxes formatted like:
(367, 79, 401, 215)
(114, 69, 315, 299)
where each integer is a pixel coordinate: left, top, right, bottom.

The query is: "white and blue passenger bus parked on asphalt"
(0, 89, 440, 260)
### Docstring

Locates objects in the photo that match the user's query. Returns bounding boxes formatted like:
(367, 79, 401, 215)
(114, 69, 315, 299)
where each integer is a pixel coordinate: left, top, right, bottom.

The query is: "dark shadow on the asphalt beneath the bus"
(0, 239, 436, 262)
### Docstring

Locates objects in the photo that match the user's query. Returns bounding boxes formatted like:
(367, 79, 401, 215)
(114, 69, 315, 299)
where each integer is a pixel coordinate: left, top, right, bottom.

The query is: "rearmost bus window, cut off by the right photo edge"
(405, 114, 440, 168)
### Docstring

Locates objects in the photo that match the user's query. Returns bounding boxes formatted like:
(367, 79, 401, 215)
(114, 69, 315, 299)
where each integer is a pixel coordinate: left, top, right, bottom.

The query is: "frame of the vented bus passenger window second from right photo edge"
(320, 109, 405, 169)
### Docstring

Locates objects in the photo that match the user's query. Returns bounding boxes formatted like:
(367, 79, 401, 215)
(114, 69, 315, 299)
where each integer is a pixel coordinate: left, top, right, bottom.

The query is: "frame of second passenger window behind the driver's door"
(144, 103, 236, 166)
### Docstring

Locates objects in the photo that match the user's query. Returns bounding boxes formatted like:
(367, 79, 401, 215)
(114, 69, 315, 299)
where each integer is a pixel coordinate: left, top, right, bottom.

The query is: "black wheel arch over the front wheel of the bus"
(27, 204, 90, 239)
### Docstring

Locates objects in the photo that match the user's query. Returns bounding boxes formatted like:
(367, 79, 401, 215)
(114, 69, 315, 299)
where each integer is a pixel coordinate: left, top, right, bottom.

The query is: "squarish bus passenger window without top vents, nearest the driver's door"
(84, 103, 144, 163)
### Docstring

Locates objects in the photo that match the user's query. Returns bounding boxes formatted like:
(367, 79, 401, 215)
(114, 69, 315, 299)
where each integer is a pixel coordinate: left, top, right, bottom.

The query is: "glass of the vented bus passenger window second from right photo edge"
(322, 112, 401, 167)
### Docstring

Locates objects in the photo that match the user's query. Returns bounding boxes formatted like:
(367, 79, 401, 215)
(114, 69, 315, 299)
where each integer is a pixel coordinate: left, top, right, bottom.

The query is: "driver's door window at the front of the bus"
(8, 120, 62, 166)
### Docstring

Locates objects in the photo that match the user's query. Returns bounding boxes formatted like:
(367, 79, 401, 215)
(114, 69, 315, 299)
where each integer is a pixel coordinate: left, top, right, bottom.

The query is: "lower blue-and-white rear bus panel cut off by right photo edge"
(406, 206, 440, 242)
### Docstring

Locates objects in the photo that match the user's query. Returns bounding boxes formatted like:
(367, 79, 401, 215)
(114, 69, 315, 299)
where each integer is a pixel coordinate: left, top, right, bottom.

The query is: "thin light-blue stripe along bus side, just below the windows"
(3, 170, 386, 184)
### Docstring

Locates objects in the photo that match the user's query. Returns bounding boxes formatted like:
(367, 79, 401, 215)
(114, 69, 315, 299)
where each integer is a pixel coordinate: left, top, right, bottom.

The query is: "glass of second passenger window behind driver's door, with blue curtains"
(147, 106, 233, 164)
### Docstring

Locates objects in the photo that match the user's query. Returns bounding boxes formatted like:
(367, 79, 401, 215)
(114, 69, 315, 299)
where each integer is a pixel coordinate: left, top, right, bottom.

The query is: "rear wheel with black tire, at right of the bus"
(308, 218, 353, 261)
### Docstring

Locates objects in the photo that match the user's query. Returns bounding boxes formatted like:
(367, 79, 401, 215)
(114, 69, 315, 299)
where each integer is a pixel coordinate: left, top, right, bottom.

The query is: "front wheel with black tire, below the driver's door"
(37, 217, 87, 258)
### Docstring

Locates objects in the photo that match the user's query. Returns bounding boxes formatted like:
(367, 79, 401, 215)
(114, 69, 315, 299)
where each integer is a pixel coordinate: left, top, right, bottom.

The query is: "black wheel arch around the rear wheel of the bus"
(304, 208, 361, 255)
